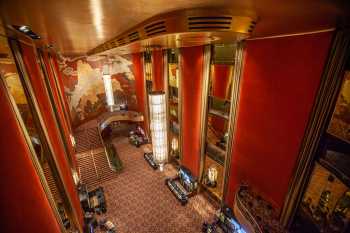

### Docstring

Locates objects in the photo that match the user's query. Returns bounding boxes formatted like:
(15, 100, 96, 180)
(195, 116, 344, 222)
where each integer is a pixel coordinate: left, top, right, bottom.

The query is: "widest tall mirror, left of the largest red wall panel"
(202, 44, 236, 201)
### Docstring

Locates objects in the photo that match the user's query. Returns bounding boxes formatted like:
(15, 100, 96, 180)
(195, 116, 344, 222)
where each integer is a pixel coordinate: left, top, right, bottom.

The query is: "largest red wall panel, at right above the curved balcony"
(226, 32, 332, 209)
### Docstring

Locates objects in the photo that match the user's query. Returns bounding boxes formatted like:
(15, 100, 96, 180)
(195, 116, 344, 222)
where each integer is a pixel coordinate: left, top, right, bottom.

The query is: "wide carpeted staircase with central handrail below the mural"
(75, 127, 117, 189)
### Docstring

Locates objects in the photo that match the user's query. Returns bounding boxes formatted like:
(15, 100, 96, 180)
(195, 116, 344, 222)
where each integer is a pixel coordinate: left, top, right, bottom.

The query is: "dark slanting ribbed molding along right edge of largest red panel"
(280, 30, 350, 228)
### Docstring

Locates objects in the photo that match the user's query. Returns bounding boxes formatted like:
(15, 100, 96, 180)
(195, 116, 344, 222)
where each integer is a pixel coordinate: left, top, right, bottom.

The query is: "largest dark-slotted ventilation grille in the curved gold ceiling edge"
(188, 16, 232, 31)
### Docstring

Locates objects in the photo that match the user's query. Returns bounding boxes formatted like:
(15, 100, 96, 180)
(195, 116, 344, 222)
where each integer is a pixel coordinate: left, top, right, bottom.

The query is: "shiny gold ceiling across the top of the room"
(0, 0, 350, 55)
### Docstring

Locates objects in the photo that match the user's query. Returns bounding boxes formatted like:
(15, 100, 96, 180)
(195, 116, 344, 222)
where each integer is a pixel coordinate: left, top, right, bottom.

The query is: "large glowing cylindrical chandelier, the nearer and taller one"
(148, 91, 168, 171)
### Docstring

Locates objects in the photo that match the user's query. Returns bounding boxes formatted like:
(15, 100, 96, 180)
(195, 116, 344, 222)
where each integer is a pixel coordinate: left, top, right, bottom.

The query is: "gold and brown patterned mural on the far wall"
(59, 55, 137, 126)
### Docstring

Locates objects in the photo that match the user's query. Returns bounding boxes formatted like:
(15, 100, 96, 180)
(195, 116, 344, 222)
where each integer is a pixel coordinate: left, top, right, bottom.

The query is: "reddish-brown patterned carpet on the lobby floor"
(94, 138, 217, 233)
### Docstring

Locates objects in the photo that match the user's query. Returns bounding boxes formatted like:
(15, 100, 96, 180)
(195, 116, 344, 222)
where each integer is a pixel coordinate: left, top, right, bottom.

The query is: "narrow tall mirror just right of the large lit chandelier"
(167, 49, 181, 165)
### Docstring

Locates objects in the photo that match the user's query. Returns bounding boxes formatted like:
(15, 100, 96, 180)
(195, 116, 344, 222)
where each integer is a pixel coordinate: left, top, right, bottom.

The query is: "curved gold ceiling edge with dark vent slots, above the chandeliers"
(88, 9, 257, 55)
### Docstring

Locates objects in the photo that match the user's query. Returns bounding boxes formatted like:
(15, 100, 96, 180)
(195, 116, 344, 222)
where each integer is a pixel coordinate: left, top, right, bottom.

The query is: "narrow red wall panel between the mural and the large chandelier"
(132, 53, 149, 135)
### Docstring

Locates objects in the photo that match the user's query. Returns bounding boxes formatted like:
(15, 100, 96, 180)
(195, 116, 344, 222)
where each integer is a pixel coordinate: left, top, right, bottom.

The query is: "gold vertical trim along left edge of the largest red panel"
(221, 42, 244, 205)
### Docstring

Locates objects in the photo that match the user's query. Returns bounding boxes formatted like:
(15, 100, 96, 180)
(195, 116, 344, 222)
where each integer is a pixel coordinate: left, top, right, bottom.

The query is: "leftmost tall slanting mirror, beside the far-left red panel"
(0, 36, 77, 231)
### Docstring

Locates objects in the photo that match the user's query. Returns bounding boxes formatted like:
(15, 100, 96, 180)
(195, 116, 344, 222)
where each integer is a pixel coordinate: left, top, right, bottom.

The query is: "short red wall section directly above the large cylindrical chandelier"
(152, 50, 165, 91)
